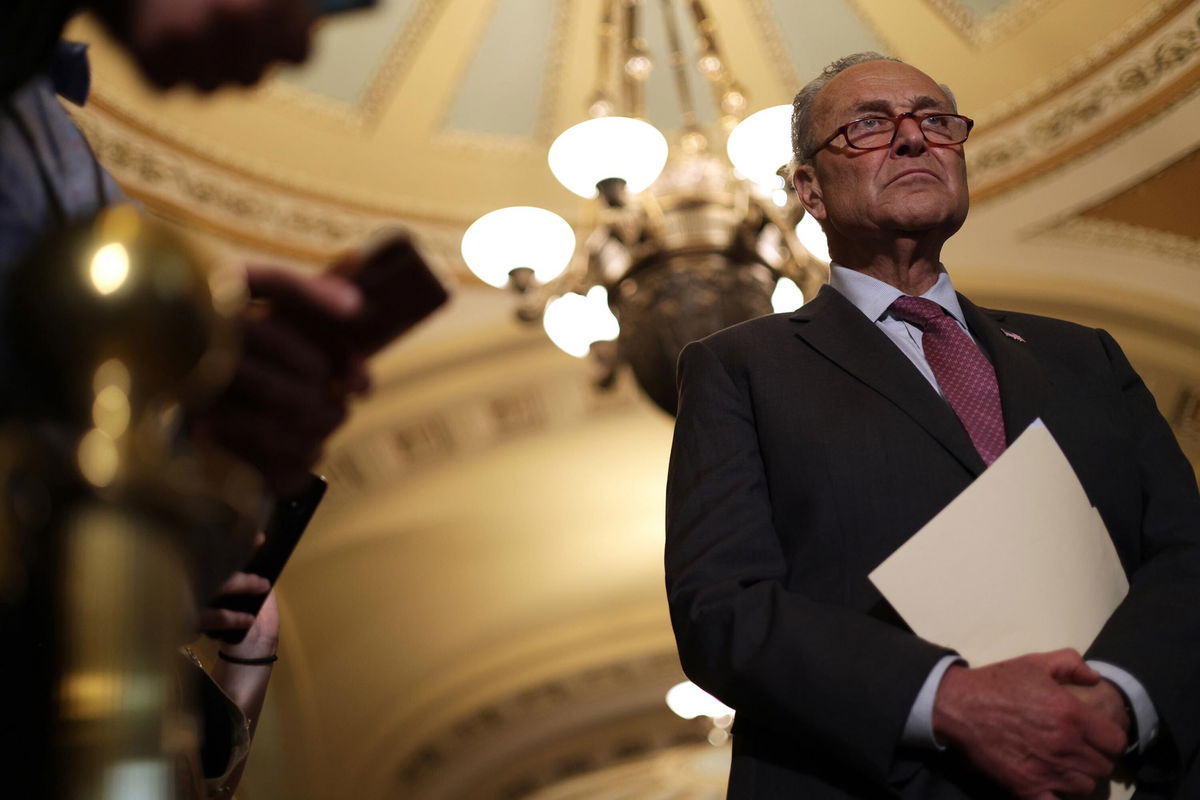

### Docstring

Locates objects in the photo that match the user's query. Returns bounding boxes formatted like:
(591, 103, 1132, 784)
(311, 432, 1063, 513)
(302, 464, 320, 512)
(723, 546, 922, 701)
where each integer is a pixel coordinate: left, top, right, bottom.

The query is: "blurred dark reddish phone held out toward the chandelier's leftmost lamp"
(342, 234, 450, 355)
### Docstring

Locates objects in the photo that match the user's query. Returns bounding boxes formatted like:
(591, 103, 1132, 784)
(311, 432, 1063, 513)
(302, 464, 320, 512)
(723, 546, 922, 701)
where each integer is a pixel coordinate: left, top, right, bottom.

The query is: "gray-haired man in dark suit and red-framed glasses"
(666, 54, 1200, 800)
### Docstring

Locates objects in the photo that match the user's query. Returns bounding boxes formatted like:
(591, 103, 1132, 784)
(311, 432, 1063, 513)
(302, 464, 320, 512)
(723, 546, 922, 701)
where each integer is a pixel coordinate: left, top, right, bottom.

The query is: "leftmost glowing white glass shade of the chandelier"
(462, 205, 575, 288)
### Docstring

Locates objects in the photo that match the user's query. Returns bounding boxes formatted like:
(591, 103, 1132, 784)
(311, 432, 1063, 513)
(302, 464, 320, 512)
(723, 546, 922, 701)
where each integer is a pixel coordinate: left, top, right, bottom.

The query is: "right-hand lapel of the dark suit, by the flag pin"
(959, 295, 1050, 444)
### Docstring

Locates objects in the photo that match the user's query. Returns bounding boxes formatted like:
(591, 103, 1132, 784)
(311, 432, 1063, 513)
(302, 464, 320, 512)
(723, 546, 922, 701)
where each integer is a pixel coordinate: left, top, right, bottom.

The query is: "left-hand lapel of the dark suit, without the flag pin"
(791, 285, 984, 475)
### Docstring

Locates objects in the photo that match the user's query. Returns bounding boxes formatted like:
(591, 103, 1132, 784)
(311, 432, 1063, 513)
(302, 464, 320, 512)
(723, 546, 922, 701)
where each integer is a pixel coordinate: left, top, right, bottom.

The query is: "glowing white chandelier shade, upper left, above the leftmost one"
(548, 116, 667, 197)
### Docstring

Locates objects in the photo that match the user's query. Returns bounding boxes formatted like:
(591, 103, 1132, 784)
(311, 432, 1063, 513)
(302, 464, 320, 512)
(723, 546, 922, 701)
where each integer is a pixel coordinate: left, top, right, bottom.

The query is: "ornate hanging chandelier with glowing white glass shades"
(453, 0, 828, 414)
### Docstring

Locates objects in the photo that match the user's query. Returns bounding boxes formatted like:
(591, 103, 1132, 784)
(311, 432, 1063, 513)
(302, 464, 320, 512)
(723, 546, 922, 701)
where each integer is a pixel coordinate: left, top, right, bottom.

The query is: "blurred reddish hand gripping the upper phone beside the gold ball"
(192, 266, 370, 497)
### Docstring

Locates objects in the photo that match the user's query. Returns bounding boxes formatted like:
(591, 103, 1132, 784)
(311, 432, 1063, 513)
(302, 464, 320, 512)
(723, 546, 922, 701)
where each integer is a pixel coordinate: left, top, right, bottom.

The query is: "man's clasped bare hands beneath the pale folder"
(934, 649, 1126, 800)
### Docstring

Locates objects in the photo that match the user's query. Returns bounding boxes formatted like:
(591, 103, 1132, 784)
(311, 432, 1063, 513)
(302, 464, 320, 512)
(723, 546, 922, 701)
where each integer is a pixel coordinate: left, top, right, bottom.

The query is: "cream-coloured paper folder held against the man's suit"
(870, 420, 1133, 800)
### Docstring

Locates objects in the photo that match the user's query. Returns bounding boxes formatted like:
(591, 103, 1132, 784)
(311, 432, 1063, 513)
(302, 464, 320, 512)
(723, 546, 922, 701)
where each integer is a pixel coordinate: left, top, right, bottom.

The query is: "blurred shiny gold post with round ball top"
(0, 206, 259, 800)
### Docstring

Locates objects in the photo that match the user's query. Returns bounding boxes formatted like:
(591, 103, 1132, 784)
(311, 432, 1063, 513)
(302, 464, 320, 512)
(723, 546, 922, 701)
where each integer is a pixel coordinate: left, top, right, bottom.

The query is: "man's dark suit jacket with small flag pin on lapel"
(666, 287, 1200, 800)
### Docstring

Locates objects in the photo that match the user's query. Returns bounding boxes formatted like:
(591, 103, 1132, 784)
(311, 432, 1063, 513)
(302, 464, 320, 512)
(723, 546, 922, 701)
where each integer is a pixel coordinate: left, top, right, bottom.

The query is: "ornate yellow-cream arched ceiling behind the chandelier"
(60, 0, 1200, 800)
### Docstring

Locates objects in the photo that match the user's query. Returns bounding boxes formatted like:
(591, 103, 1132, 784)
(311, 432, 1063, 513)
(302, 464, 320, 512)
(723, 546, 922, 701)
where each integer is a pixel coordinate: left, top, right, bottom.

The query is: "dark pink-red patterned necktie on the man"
(892, 296, 1006, 464)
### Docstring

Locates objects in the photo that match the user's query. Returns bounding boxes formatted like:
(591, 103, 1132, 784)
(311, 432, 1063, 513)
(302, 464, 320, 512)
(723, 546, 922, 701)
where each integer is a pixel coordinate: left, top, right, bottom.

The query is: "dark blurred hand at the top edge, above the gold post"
(95, 0, 314, 91)
